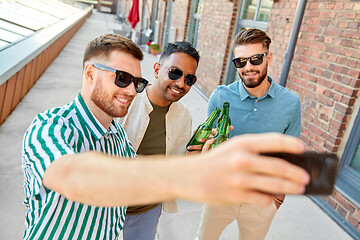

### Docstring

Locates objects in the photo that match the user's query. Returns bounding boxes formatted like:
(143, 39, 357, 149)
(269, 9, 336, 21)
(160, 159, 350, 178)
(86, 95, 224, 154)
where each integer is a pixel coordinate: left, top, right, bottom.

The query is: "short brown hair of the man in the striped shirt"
(83, 33, 144, 67)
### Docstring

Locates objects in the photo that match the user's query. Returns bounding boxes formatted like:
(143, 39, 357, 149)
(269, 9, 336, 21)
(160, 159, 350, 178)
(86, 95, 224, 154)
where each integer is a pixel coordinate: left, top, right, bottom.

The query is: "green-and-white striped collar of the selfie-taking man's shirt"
(74, 93, 118, 140)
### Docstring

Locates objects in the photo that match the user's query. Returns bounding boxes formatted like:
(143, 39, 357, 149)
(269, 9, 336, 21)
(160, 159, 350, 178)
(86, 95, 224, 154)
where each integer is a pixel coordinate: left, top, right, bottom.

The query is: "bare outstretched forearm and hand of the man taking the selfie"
(43, 133, 309, 206)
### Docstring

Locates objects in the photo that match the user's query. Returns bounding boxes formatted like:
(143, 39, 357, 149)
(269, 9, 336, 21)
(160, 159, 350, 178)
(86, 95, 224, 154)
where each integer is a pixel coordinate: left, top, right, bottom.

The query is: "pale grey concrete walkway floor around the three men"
(0, 9, 352, 240)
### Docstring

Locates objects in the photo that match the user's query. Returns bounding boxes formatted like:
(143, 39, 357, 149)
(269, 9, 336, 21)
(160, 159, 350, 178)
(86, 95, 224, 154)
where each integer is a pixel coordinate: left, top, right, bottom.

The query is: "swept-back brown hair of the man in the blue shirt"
(231, 28, 271, 50)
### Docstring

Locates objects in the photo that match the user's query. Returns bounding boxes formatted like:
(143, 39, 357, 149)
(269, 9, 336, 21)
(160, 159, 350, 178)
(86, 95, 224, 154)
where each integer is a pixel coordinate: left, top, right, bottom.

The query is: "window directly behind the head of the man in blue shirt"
(226, 0, 273, 84)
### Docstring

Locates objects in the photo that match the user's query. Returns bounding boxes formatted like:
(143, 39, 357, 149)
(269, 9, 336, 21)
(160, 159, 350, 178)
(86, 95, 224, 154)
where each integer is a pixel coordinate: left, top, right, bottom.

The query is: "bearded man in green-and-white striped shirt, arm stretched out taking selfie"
(22, 34, 309, 239)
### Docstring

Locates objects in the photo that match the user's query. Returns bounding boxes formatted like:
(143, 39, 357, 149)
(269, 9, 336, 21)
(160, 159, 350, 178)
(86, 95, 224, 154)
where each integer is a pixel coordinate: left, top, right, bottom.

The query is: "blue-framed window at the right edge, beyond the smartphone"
(336, 111, 360, 206)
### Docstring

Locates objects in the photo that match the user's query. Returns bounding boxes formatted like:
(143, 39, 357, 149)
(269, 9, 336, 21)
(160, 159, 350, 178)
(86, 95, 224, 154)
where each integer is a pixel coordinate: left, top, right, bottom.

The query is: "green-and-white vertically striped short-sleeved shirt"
(22, 94, 135, 240)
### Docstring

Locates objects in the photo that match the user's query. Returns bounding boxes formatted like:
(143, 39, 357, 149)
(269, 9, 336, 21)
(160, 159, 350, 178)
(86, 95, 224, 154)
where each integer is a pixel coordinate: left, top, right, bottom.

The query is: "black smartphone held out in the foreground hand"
(262, 152, 339, 195)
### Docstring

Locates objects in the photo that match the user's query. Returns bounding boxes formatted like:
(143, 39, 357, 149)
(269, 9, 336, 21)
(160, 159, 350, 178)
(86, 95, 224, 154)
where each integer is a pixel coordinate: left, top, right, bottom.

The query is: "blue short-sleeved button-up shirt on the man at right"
(208, 77, 301, 137)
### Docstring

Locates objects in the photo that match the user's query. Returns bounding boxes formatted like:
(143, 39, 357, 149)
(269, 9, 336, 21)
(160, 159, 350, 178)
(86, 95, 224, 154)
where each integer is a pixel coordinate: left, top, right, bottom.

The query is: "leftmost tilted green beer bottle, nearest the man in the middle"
(186, 108, 220, 150)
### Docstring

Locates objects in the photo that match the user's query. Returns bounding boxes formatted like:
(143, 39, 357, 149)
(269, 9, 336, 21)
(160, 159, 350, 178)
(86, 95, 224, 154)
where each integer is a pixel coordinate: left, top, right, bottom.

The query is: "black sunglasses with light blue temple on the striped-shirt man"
(92, 63, 149, 93)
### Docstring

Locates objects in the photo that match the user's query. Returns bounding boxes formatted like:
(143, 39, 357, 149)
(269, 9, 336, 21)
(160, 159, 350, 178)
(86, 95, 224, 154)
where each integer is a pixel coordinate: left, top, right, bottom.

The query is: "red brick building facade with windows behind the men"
(118, 0, 360, 237)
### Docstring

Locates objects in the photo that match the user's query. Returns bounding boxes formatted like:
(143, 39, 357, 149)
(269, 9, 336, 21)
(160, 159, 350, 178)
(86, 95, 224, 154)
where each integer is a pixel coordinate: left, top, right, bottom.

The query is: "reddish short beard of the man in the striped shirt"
(90, 81, 127, 118)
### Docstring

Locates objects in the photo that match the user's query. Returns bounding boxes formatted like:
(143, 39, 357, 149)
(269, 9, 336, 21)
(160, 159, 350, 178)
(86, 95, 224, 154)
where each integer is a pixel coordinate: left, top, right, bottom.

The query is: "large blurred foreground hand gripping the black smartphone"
(177, 133, 310, 206)
